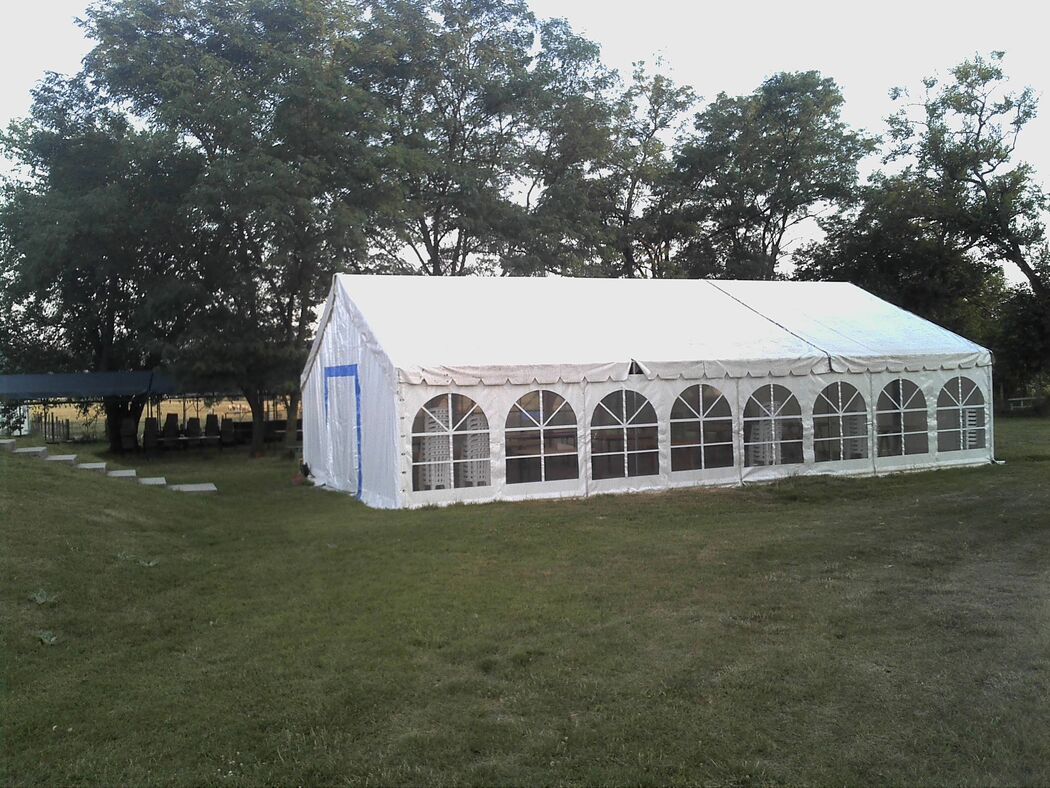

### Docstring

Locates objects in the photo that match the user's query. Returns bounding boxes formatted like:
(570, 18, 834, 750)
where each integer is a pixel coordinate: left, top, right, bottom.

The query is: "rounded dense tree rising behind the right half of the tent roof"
(676, 71, 875, 279)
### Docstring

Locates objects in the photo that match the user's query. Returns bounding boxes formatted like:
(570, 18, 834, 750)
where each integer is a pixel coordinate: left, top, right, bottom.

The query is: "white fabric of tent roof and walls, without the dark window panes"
(302, 274, 992, 507)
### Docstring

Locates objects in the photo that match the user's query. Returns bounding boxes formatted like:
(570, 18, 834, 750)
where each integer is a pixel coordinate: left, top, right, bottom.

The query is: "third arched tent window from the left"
(591, 389, 659, 479)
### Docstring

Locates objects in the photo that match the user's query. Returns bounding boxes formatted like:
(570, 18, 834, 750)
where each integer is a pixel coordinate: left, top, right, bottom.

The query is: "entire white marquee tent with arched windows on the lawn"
(302, 274, 992, 509)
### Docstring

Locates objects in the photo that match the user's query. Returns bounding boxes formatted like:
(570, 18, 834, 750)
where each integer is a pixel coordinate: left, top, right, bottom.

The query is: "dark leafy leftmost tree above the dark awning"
(0, 75, 201, 451)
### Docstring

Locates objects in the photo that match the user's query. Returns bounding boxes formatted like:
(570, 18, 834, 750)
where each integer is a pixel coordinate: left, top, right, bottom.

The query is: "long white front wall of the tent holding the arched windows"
(400, 367, 993, 506)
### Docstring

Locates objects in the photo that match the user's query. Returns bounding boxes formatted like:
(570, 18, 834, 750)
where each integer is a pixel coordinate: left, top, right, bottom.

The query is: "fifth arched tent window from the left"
(743, 383, 802, 466)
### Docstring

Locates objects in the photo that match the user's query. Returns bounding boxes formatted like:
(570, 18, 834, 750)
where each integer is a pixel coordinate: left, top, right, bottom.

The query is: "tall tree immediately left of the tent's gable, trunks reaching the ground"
(86, 0, 384, 451)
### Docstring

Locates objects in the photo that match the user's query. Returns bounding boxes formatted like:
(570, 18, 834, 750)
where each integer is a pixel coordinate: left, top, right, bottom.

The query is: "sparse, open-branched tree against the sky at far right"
(886, 51, 1050, 303)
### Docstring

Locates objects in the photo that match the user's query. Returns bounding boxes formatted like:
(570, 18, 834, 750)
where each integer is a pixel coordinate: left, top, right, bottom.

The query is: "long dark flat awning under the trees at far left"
(0, 372, 178, 401)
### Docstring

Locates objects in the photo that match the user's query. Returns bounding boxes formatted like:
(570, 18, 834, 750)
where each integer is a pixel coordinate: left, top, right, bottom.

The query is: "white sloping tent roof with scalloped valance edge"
(308, 274, 991, 385)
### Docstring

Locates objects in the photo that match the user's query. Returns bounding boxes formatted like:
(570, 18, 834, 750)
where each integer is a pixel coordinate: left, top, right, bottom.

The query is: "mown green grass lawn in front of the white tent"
(0, 419, 1050, 785)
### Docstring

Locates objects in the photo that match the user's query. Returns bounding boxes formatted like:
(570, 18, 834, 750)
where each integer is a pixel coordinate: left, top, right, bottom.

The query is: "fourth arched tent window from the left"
(671, 386, 733, 471)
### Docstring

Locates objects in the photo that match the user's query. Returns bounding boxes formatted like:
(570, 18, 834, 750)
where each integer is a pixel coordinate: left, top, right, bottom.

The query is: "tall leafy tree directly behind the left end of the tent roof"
(352, 0, 610, 275)
